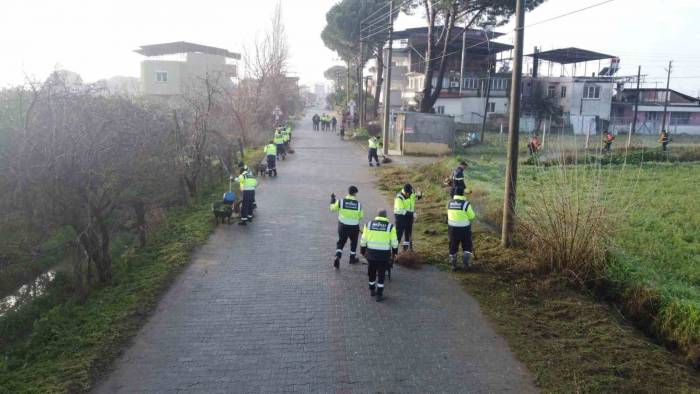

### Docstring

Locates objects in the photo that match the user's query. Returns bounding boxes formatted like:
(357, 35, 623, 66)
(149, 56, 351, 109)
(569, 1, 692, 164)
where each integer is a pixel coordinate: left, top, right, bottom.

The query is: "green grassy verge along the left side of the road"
(0, 190, 219, 393)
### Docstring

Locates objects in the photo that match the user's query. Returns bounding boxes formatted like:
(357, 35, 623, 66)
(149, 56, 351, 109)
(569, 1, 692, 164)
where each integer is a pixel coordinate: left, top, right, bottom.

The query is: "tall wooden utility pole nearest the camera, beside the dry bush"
(501, 0, 525, 247)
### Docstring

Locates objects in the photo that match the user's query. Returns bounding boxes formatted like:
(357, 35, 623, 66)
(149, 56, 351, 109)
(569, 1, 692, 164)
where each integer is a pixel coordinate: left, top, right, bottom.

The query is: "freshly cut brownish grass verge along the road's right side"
(380, 159, 700, 392)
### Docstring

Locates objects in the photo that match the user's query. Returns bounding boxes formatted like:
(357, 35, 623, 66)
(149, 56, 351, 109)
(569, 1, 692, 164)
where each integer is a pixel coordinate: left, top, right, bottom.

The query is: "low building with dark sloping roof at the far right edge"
(610, 85, 700, 135)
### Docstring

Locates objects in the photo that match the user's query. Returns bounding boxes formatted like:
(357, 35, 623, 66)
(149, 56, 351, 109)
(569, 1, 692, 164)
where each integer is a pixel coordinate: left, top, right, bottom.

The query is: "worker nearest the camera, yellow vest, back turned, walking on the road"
(360, 210, 399, 302)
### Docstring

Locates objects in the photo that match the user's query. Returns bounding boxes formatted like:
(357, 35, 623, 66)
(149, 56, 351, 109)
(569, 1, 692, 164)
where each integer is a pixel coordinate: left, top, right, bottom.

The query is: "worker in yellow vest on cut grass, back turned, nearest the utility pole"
(447, 187, 476, 271)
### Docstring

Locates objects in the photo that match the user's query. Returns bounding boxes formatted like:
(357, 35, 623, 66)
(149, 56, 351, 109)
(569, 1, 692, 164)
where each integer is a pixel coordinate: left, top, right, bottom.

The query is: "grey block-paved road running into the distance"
(96, 114, 535, 393)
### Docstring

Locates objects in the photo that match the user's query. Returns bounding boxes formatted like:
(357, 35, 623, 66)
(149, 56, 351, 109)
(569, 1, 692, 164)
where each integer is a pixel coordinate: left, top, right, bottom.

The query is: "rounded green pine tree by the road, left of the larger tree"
(321, 0, 398, 117)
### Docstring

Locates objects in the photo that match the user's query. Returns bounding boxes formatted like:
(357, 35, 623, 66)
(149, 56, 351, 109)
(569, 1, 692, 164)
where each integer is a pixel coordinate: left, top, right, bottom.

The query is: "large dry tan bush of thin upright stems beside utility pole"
(518, 165, 614, 284)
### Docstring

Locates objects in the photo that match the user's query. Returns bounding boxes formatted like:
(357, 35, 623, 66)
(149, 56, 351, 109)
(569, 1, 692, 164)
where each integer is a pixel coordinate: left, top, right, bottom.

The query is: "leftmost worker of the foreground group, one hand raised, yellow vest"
(330, 186, 364, 269)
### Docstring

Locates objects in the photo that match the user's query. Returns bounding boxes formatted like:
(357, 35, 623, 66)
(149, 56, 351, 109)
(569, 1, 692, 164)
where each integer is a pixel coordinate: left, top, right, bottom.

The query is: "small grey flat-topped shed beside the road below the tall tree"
(390, 112, 455, 156)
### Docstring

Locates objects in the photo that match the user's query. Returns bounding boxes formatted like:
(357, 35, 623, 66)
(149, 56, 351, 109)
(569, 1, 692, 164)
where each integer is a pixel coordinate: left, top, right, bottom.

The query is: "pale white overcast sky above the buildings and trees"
(0, 0, 700, 96)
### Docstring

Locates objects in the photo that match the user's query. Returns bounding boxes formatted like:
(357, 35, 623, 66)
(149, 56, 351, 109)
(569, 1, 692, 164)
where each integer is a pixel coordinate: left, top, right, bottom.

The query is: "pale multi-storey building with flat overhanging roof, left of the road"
(135, 41, 241, 96)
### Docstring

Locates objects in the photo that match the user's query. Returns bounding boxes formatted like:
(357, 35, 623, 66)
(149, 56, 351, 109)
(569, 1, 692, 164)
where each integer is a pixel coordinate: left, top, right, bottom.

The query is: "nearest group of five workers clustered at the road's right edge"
(330, 162, 476, 302)
